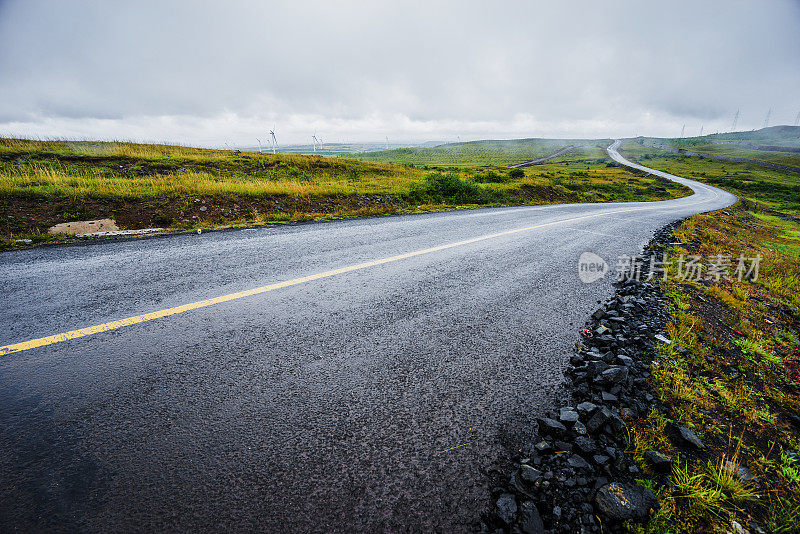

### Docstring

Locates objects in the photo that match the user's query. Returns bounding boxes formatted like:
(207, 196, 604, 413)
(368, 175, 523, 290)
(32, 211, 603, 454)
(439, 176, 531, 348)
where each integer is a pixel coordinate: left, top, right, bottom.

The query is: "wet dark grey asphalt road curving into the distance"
(0, 144, 735, 532)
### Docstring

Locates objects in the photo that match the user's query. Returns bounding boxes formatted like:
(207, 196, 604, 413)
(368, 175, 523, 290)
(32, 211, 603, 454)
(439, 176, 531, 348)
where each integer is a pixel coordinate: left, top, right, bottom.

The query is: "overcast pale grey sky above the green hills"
(0, 0, 800, 146)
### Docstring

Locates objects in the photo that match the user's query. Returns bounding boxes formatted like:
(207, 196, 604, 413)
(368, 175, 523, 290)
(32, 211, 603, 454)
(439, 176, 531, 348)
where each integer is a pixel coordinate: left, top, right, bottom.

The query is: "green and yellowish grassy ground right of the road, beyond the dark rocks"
(623, 130, 800, 533)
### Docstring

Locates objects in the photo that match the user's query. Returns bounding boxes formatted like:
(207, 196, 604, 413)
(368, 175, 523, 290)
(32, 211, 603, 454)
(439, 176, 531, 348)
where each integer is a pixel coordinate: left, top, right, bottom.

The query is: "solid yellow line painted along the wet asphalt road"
(0, 186, 724, 356)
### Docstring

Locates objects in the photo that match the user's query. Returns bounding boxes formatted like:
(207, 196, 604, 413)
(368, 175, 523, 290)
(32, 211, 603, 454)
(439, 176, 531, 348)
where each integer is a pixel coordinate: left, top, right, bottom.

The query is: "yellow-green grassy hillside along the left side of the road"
(0, 139, 688, 247)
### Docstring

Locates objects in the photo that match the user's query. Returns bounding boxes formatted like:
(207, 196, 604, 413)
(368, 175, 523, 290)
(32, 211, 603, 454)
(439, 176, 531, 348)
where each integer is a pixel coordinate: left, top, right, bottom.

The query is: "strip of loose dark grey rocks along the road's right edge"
(482, 223, 703, 533)
